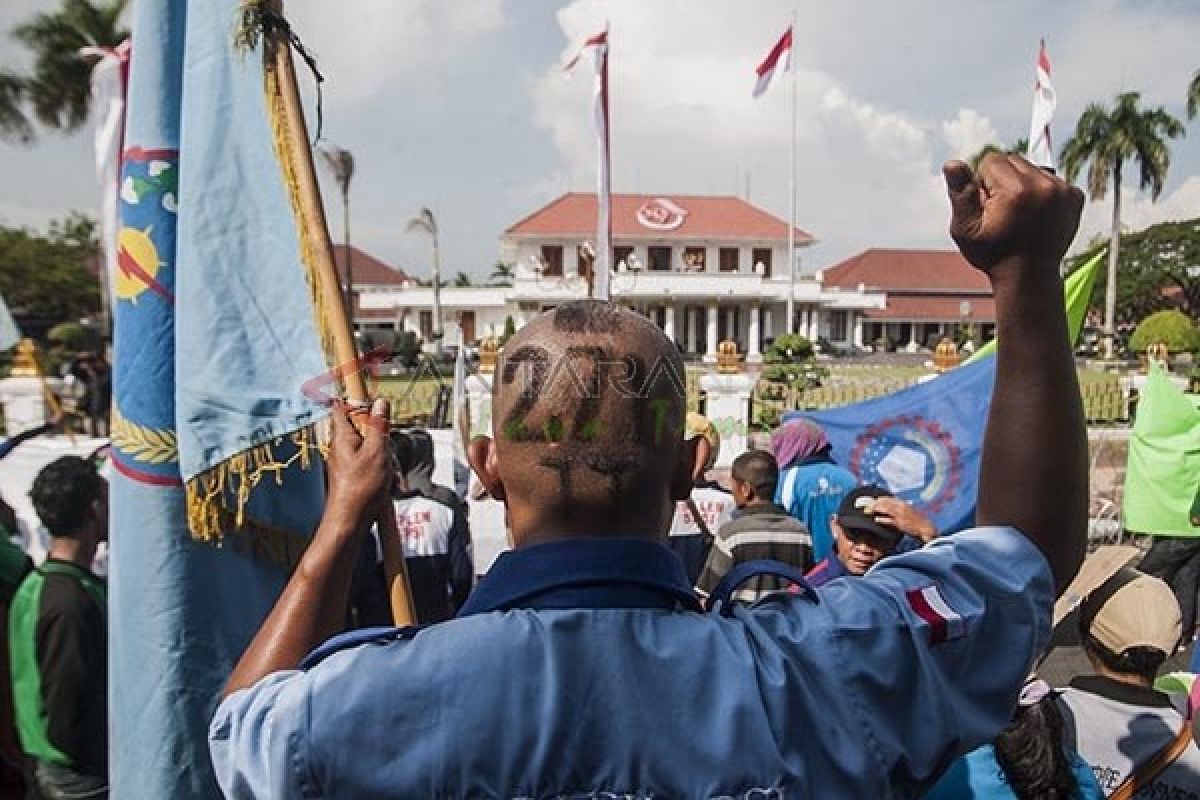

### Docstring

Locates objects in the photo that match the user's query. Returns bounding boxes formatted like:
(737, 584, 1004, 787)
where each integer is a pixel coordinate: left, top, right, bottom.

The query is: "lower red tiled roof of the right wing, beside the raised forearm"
(822, 248, 991, 293)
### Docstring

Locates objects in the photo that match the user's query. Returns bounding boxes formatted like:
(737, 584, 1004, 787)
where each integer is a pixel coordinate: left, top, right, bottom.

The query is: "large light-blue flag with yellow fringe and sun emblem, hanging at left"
(109, 0, 326, 800)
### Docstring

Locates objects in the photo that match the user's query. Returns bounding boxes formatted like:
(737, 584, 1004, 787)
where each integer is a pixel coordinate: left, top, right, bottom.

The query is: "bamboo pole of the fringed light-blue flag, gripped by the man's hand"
(272, 7, 416, 627)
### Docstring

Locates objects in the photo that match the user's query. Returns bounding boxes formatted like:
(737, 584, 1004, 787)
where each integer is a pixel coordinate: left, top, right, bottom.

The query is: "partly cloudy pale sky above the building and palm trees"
(0, 0, 1200, 276)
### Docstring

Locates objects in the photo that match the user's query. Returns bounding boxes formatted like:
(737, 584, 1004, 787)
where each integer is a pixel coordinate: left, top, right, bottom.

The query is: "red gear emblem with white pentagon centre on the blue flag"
(850, 414, 962, 513)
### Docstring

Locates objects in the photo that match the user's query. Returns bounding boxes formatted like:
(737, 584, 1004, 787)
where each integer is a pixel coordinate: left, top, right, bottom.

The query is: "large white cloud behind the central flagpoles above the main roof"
(534, 0, 974, 266)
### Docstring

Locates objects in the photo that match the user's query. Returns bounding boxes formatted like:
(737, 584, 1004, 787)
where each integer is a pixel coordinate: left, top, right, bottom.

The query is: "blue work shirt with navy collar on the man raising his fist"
(209, 528, 1054, 800)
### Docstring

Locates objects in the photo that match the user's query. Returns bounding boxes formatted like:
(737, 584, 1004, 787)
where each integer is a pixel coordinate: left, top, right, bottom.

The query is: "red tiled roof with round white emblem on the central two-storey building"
(504, 192, 816, 245)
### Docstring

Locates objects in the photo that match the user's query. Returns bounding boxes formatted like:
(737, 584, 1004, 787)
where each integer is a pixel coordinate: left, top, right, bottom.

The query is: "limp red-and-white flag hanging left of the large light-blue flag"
(79, 40, 132, 311)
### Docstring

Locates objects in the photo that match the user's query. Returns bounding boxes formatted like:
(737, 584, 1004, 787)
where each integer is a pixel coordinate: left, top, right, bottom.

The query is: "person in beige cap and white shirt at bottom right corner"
(1058, 567, 1200, 798)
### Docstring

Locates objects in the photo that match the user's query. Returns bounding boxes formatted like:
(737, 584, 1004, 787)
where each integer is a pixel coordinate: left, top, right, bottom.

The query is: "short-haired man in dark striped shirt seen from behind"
(696, 450, 812, 603)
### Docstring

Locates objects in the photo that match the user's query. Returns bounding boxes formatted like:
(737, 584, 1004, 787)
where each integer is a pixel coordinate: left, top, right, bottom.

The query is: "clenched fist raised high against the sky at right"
(942, 154, 1084, 278)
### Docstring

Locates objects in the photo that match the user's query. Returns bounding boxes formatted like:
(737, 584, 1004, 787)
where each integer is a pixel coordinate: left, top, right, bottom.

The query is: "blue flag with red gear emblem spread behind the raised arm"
(784, 356, 996, 534)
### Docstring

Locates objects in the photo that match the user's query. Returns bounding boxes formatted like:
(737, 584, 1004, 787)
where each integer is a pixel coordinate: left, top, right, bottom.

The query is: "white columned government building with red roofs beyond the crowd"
(348, 193, 995, 363)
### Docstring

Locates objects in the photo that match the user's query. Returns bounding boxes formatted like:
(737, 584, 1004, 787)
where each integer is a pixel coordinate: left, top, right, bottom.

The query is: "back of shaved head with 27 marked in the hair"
(493, 301, 686, 527)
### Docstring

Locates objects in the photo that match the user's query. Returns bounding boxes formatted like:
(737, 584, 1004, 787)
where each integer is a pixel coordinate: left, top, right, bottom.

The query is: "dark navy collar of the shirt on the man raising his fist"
(458, 537, 701, 616)
